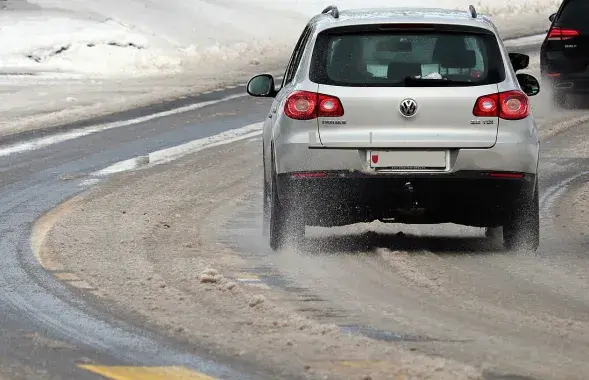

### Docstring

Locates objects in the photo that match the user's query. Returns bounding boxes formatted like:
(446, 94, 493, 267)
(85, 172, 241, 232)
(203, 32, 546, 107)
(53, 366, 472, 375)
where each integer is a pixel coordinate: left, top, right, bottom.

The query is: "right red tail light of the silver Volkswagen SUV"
(472, 91, 530, 120)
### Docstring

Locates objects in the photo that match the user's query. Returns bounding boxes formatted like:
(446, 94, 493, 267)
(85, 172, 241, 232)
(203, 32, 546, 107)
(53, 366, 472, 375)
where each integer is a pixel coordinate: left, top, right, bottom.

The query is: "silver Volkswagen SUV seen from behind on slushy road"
(247, 6, 540, 250)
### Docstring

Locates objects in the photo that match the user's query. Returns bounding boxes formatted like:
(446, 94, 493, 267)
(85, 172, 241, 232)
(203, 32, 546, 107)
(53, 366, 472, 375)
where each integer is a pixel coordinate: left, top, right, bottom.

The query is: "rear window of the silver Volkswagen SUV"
(310, 26, 505, 87)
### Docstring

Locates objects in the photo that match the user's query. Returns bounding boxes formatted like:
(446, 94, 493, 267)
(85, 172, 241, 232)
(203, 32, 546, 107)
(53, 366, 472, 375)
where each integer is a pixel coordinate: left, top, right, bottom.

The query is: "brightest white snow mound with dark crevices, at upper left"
(0, 12, 176, 75)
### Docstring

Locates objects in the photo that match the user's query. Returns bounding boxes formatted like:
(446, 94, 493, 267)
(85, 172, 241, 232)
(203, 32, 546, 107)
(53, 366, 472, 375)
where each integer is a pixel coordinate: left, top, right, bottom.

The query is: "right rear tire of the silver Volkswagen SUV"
(503, 183, 540, 252)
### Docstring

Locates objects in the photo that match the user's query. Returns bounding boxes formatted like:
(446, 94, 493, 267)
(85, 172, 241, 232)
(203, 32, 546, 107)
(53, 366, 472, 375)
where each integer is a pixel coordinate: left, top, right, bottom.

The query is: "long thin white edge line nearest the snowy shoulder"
(0, 94, 248, 157)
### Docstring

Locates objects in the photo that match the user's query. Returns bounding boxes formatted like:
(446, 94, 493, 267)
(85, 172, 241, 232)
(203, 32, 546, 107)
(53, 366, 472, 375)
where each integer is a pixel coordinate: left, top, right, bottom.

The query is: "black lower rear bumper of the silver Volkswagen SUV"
(277, 171, 536, 227)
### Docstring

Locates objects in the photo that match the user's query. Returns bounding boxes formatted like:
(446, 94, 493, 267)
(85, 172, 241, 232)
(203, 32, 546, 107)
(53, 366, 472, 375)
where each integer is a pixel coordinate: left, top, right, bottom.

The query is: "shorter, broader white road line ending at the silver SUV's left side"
(79, 123, 264, 182)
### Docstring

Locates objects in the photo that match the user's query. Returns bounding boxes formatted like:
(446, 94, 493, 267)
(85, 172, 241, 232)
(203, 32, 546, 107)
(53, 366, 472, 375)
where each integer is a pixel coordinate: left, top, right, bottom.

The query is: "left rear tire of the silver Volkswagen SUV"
(268, 157, 305, 251)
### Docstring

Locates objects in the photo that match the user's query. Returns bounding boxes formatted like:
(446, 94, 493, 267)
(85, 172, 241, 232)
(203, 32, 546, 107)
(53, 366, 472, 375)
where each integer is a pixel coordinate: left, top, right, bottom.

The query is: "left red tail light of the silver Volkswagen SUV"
(284, 91, 344, 120)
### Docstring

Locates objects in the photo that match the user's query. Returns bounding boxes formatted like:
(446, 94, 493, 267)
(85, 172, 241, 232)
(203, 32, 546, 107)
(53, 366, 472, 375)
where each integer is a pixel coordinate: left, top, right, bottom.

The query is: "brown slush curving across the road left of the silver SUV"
(38, 140, 481, 380)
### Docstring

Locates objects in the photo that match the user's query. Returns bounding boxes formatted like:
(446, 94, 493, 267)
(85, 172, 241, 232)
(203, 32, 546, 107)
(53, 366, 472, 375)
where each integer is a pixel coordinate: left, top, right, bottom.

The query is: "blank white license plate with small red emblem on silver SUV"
(368, 150, 447, 170)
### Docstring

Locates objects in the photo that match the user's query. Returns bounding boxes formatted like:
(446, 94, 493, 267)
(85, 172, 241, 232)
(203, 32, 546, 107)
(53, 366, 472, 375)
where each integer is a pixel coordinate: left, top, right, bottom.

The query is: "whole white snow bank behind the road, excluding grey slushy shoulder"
(0, 0, 561, 77)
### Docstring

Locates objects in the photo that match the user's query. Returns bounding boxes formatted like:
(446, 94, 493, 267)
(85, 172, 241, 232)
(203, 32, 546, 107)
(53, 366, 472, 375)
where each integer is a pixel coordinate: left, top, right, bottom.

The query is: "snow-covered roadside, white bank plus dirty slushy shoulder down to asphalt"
(0, 0, 561, 134)
